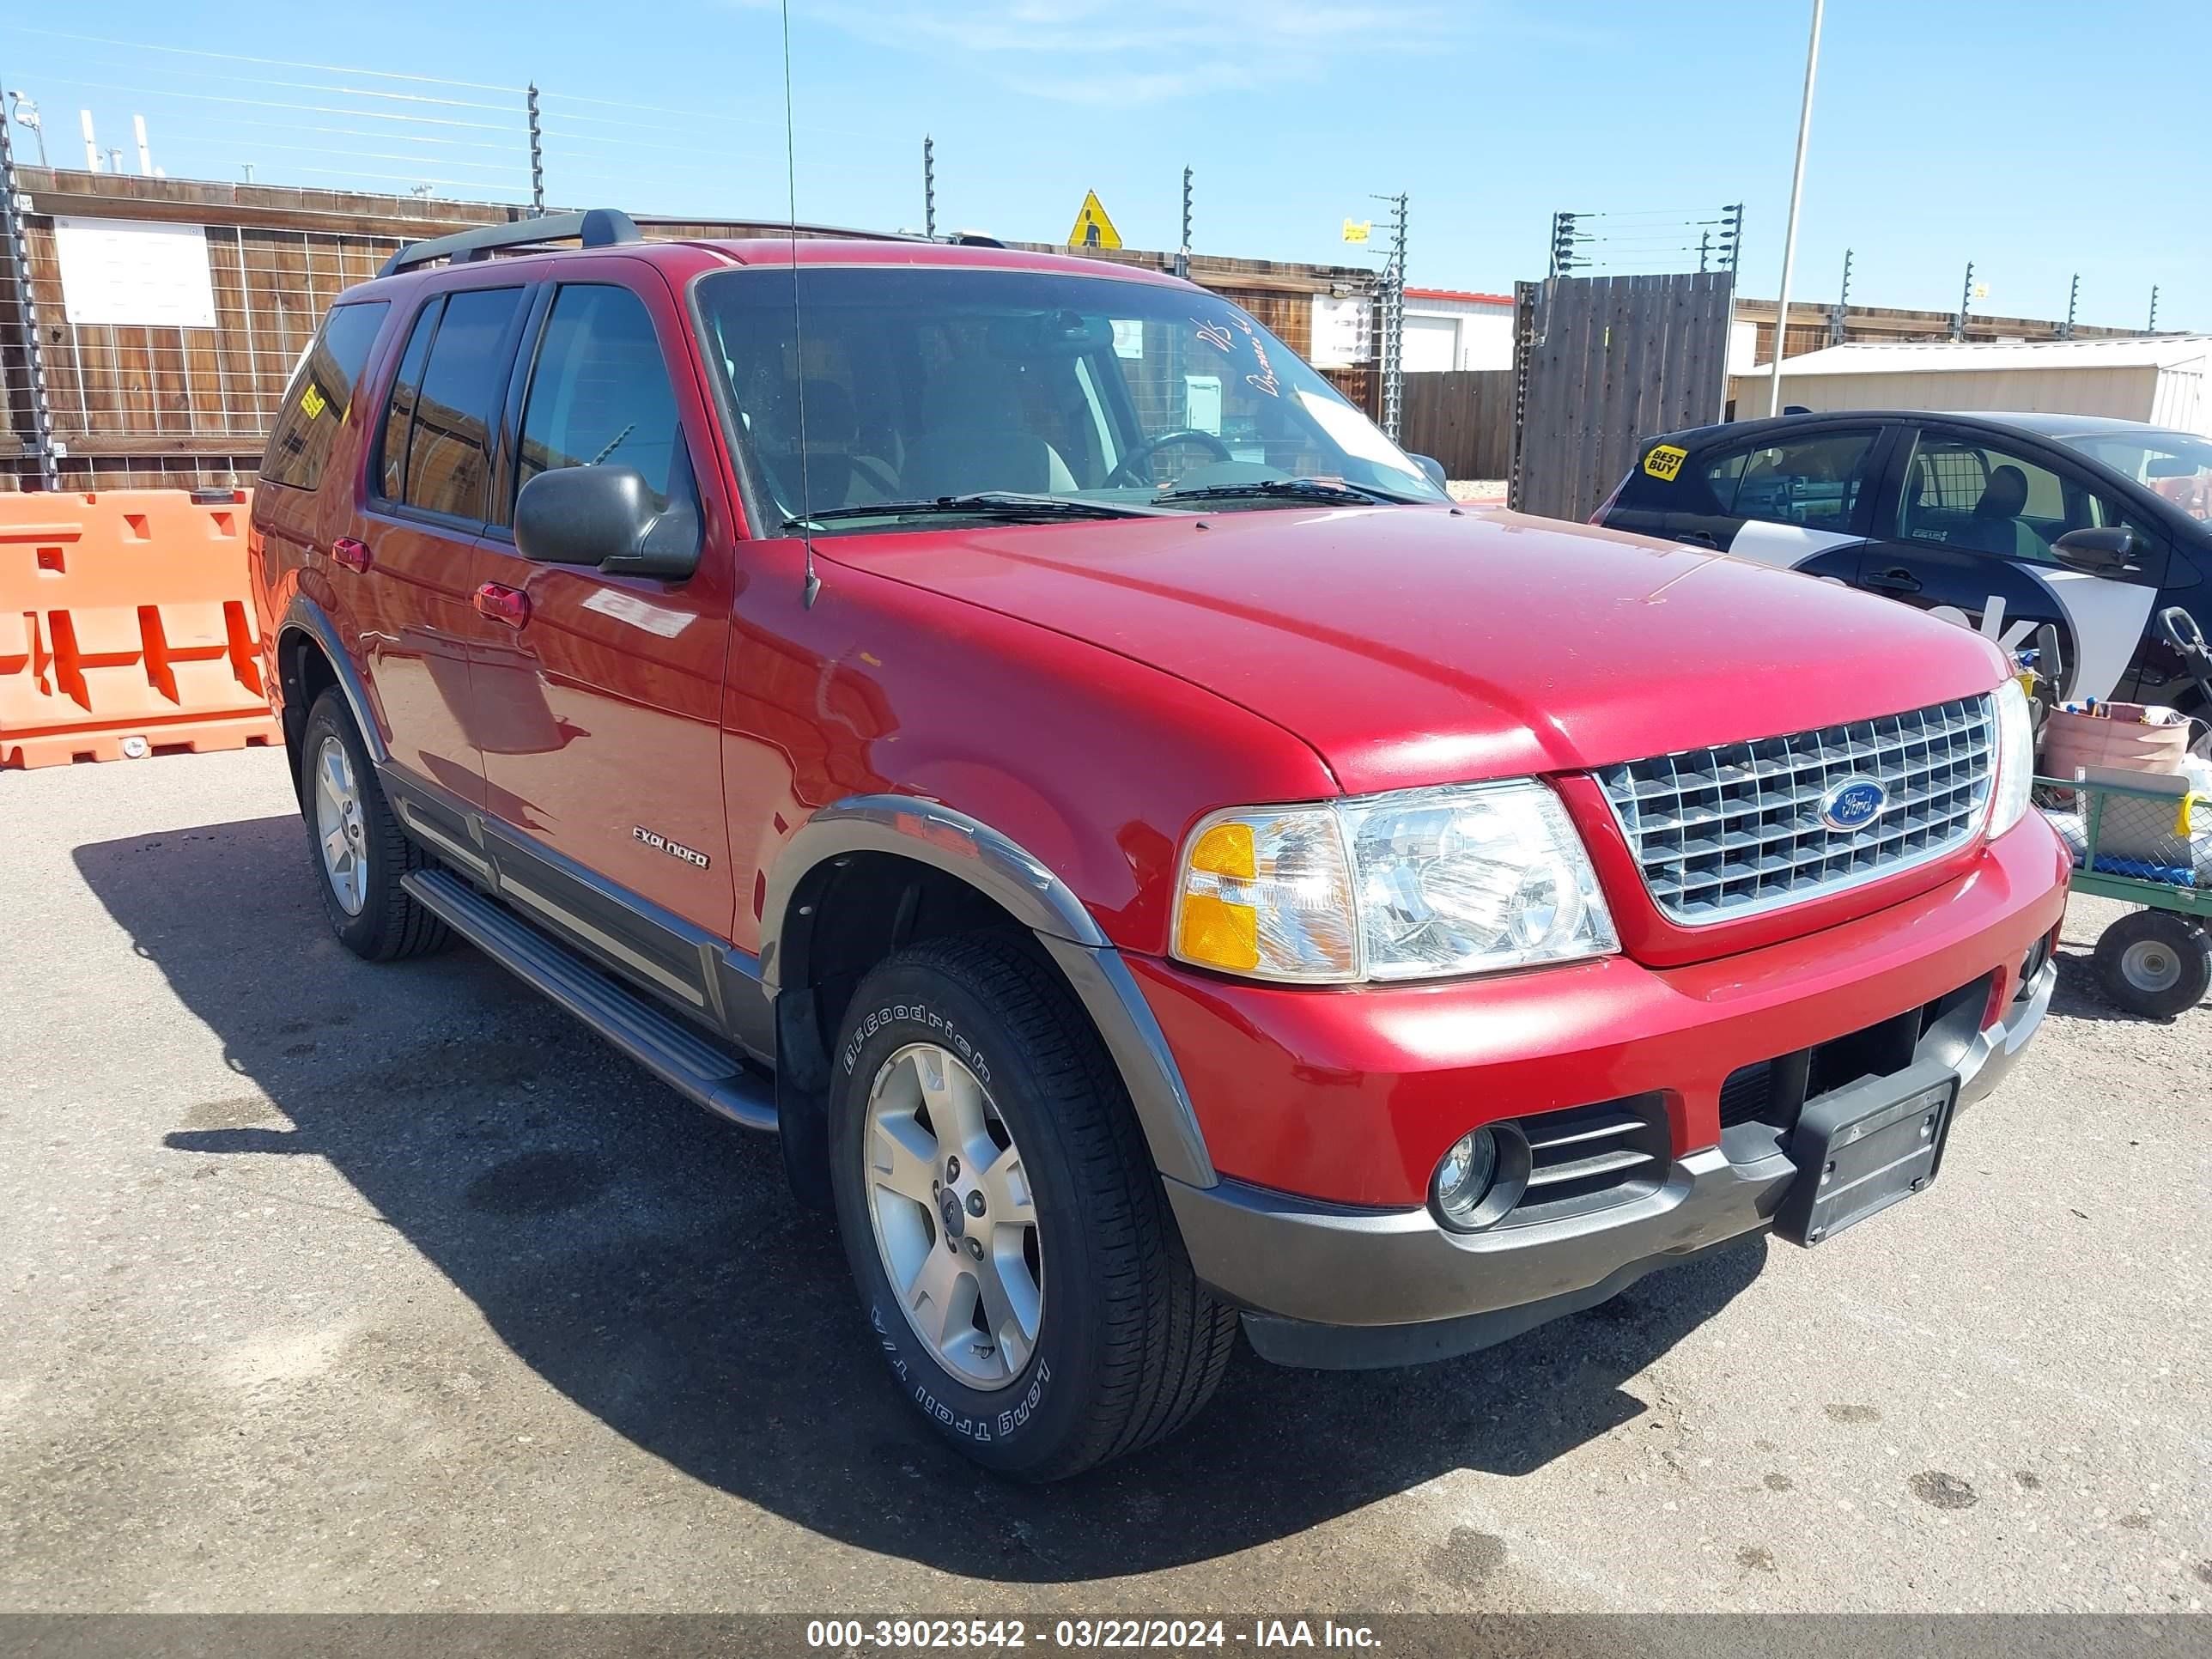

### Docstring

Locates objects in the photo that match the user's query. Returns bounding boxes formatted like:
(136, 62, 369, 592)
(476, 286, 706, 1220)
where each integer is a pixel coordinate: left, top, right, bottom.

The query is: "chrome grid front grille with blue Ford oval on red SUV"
(1597, 696, 1996, 927)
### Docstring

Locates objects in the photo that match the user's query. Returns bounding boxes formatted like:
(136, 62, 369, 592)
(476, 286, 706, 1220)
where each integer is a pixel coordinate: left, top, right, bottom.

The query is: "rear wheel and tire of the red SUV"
(299, 688, 452, 963)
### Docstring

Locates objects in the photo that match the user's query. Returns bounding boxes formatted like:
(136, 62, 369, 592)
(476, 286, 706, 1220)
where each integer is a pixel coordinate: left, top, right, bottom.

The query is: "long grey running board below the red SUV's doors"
(400, 869, 776, 1130)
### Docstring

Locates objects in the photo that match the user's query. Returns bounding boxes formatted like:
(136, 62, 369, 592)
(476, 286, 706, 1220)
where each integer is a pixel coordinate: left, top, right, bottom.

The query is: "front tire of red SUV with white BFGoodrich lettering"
(830, 936, 1237, 1482)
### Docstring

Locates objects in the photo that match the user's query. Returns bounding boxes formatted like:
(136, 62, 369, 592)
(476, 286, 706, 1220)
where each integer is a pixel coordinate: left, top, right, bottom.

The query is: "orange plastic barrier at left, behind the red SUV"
(0, 489, 279, 768)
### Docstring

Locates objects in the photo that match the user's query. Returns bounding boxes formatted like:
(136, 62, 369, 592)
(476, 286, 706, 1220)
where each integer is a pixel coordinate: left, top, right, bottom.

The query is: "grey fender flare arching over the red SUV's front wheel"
(761, 794, 1221, 1188)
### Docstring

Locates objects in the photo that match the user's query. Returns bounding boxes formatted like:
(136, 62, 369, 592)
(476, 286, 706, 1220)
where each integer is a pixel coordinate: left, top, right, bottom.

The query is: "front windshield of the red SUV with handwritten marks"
(699, 265, 1447, 533)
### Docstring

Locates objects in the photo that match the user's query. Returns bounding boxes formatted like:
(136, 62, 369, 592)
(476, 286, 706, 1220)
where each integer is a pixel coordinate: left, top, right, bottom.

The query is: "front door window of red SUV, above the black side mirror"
(515, 283, 681, 507)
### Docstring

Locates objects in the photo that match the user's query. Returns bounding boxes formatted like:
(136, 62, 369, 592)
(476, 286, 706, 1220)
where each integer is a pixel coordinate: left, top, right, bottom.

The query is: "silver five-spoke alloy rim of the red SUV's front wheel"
(860, 1042, 1044, 1391)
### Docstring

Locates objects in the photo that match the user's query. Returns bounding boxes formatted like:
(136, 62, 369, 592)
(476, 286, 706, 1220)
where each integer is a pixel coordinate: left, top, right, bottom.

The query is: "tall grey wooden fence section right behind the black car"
(1509, 272, 1735, 520)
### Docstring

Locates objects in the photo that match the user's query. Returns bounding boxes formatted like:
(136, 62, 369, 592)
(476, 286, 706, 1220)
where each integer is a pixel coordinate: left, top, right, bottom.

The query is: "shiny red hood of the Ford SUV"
(818, 507, 2004, 792)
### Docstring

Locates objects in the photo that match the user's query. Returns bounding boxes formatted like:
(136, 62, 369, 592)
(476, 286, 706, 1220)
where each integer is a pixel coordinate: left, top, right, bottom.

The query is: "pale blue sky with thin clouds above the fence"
(0, 0, 2212, 327)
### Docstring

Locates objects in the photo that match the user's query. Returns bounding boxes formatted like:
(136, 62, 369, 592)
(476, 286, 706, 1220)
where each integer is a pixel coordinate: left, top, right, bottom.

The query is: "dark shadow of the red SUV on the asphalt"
(76, 817, 1765, 1582)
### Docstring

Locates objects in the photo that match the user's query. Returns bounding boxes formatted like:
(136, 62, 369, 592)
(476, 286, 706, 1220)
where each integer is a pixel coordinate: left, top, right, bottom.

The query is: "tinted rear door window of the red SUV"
(380, 288, 525, 520)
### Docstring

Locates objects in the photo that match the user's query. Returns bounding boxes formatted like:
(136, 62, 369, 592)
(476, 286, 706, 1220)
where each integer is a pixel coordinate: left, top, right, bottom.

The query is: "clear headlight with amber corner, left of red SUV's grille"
(1175, 781, 1620, 982)
